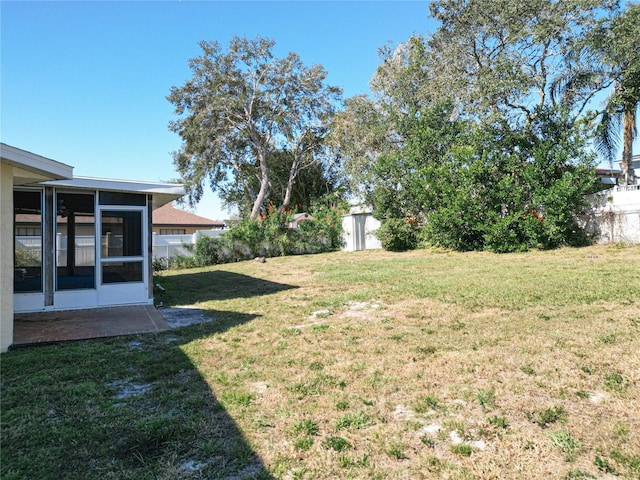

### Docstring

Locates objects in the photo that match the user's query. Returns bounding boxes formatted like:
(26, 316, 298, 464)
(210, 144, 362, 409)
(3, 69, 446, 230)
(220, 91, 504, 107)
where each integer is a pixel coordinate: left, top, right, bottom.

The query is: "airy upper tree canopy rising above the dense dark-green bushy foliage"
(332, 0, 616, 197)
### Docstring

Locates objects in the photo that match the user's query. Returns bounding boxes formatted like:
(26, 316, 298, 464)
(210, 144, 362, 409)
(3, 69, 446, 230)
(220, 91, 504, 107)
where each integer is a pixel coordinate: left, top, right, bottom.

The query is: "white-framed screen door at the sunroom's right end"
(98, 206, 148, 305)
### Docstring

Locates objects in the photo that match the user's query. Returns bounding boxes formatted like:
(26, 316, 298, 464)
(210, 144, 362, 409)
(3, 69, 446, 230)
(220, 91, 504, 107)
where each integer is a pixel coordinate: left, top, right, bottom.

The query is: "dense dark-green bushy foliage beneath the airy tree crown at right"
(372, 103, 595, 253)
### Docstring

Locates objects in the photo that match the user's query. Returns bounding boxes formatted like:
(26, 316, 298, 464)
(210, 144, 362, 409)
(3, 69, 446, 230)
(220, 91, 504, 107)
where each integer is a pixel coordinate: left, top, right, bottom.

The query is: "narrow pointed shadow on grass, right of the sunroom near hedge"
(157, 270, 298, 305)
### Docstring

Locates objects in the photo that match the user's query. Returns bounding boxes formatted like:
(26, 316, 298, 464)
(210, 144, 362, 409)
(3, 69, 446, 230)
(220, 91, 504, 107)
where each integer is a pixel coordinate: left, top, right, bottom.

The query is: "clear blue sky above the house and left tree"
(0, 0, 435, 219)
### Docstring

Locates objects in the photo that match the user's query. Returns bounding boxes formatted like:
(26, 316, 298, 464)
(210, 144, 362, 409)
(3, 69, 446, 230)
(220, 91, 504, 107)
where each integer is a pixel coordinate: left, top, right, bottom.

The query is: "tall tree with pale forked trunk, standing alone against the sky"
(167, 37, 341, 219)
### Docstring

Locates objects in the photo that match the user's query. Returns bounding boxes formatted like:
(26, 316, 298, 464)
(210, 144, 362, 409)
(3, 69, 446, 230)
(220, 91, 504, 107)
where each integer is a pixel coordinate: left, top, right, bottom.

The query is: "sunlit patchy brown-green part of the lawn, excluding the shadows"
(164, 247, 640, 479)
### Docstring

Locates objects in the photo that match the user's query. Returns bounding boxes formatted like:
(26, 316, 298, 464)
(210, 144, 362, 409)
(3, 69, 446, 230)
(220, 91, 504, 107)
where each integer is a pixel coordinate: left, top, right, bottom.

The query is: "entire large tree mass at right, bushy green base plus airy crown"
(334, 0, 617, 251)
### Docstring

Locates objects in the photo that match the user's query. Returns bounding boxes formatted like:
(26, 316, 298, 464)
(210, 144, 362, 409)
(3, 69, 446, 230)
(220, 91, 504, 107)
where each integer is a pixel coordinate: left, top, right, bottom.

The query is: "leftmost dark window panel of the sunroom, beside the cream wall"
(13, 190, 42, 293)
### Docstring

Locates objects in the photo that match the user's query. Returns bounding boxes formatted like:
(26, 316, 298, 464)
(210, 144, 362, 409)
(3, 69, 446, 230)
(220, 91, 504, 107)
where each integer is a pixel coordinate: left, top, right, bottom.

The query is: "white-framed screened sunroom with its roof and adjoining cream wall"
(1, 144, 184, 349)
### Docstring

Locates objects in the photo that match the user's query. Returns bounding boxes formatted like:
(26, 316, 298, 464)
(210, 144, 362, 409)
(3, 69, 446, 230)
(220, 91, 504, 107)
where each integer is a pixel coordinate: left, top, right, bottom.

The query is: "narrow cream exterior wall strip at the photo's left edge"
(0, 163, 13, 352)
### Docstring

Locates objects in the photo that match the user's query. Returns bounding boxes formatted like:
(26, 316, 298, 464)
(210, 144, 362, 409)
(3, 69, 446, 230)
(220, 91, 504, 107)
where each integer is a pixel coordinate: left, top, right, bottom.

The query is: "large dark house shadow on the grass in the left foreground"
(0, 316, 272, 480)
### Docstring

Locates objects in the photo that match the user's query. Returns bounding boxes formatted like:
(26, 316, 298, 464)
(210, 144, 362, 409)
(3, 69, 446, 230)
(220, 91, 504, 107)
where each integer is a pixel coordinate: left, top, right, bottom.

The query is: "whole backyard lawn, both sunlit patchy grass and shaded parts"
(0, 247, 640, 480)
